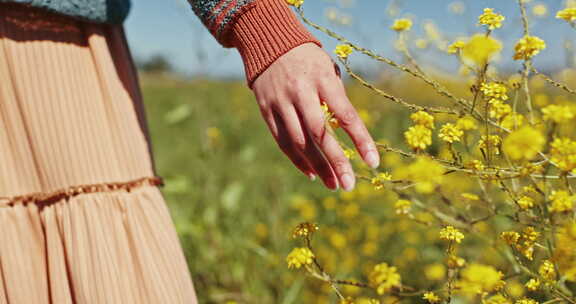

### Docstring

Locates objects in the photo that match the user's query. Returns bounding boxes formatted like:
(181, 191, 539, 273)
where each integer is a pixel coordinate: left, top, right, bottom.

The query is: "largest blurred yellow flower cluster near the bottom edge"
(458, 264, 504, 294)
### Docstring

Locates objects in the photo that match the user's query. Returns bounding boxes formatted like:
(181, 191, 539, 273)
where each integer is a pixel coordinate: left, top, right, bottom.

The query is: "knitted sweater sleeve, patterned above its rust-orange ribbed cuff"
(189, 0, 321, 87)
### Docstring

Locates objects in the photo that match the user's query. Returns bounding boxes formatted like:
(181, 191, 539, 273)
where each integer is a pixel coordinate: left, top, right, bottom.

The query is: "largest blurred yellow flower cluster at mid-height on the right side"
(502, 126, 546, 160)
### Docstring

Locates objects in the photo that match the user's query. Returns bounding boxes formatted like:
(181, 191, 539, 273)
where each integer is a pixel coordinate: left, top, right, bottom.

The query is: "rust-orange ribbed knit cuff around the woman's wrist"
(232, 0, 322, 88)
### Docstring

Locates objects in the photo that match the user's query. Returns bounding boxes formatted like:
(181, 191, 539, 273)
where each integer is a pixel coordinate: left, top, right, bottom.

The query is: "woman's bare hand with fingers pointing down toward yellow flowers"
(252, 43, 380, 190)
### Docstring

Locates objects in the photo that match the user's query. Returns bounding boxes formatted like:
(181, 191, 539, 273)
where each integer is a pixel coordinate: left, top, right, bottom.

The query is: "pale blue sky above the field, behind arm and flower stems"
(125, 0, 576, 77)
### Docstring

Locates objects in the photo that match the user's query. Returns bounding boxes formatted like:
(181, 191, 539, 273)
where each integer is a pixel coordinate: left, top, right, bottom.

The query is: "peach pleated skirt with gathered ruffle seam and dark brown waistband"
(0, 4, 196, 304)
